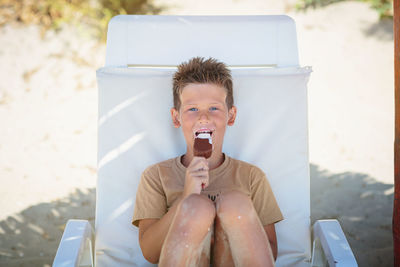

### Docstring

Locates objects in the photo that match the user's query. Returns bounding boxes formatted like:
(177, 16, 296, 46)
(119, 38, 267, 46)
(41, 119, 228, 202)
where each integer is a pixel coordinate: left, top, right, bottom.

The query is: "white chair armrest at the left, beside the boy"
(53, 220, 94, 267)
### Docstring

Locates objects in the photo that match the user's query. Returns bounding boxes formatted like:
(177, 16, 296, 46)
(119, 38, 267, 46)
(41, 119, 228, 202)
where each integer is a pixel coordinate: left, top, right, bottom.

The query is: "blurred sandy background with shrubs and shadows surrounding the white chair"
(0, 0, 394, 267)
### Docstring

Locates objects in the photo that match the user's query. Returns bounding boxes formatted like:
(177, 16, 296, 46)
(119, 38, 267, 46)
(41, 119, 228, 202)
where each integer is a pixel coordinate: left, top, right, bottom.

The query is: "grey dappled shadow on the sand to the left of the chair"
(0, 189, 96, 267)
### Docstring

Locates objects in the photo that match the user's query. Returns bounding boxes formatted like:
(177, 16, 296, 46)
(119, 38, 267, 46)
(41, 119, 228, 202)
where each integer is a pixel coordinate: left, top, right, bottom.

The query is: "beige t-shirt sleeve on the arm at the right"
(251, 168, 283, 226)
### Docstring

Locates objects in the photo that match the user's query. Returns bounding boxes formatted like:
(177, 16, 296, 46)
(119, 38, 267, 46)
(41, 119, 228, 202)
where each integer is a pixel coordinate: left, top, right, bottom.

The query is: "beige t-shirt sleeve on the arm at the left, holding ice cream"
(132, 166, 167, 227)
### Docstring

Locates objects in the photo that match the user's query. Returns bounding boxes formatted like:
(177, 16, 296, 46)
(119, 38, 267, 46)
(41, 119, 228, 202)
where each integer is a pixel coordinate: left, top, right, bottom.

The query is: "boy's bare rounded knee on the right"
(216, 190, 255, 223)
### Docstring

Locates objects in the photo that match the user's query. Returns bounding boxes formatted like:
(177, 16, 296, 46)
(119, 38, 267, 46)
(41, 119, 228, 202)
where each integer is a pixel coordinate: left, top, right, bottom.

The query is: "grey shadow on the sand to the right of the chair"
(310, 164, 393, 266)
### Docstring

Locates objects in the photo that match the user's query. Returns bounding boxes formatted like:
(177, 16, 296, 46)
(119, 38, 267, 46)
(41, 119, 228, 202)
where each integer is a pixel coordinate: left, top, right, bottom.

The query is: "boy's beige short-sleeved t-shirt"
(132, 155, 283, 226)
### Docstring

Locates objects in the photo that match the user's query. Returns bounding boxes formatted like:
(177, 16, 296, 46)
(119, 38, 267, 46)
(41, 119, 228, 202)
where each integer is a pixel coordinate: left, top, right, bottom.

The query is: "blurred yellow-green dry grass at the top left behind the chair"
(0, 0, 162, 41)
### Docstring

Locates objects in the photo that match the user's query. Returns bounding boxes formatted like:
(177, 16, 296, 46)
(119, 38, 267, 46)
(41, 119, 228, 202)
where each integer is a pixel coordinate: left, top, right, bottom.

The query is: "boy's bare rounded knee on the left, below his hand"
(178, 194, 215, 230)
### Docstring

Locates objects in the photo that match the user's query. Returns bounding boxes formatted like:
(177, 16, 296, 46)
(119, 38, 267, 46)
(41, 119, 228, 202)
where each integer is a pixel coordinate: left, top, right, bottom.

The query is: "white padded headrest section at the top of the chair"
(106, 15, 299, 67)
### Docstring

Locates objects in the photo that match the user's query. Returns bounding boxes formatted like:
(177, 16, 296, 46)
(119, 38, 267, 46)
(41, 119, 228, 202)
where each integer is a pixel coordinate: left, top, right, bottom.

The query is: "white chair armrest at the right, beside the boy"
(311, 220, 358, 267)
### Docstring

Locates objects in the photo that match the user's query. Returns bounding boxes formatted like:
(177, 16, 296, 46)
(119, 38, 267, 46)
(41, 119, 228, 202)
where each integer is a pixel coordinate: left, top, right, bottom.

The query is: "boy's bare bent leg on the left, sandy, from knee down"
(159, 194, 215, 266)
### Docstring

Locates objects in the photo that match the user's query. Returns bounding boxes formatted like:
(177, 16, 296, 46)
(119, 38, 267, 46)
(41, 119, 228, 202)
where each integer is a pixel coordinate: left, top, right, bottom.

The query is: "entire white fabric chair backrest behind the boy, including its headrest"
(95, 15, 311, 267)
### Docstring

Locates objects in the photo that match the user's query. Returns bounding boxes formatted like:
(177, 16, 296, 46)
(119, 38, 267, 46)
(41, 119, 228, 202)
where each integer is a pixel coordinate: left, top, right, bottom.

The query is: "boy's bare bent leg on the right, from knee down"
(214, 191, 274, 266)
